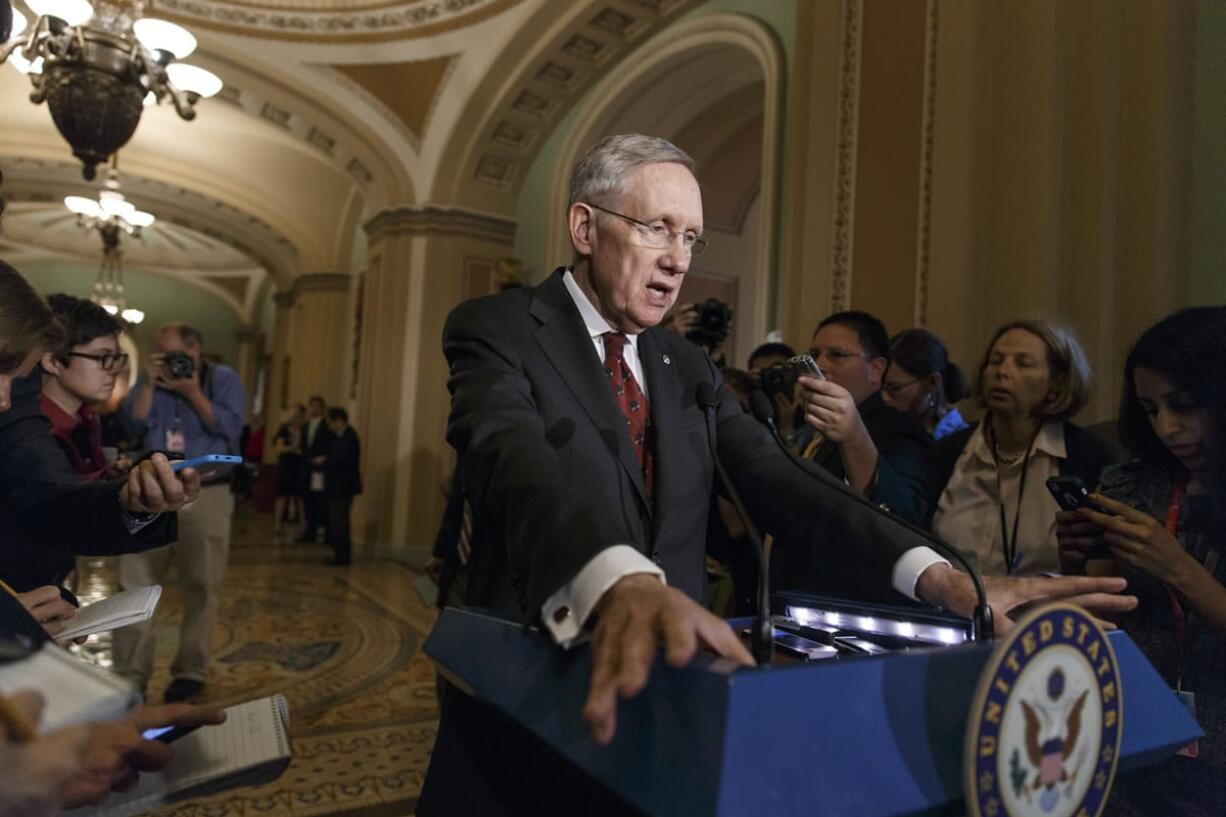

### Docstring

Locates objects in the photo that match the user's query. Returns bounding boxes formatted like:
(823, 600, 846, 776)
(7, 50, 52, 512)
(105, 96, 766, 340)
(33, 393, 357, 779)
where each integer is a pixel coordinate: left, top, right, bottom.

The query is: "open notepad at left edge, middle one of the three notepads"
(0, 642, 141, 732)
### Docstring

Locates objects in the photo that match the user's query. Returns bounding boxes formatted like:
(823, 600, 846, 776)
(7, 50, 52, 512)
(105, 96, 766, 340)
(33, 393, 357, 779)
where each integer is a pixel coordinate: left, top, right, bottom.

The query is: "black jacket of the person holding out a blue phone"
(0, 367, 178, 593)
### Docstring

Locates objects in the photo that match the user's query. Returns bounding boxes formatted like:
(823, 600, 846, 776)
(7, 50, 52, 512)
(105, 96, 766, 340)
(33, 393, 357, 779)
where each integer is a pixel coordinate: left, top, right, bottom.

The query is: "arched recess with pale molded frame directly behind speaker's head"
(539, 13, 783, 362)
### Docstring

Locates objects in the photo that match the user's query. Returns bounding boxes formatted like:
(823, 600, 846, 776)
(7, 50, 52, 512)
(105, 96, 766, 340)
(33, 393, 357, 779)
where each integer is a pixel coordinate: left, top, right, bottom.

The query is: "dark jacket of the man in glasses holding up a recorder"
(805, 391, 932, 525)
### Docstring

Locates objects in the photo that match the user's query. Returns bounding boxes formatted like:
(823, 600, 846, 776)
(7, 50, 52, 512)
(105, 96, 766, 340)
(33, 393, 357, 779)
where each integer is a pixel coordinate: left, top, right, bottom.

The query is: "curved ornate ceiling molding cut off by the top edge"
(157, 0, 521, 43)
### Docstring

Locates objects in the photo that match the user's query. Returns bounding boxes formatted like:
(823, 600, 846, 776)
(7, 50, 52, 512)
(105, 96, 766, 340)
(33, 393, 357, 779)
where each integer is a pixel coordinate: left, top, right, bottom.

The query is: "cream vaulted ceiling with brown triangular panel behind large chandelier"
(0, 0, 699, 288)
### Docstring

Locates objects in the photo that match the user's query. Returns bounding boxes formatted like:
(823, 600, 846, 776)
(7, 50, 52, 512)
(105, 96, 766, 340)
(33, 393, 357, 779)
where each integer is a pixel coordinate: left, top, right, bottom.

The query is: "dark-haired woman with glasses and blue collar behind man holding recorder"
(881, 329, 971, 439)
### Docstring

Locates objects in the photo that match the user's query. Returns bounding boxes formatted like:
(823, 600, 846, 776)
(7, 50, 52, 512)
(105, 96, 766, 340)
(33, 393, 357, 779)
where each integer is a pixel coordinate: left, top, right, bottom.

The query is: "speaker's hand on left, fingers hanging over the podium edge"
(584, 573, 754, 746)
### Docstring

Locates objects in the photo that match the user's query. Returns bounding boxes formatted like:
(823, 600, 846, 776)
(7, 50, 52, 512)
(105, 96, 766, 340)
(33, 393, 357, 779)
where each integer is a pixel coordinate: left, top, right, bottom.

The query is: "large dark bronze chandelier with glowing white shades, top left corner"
(0, 0, 222, 179)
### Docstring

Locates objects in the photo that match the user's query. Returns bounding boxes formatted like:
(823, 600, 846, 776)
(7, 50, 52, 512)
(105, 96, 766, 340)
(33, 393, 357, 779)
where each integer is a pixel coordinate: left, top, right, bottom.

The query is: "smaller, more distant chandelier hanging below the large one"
(64, 169, 156, 324)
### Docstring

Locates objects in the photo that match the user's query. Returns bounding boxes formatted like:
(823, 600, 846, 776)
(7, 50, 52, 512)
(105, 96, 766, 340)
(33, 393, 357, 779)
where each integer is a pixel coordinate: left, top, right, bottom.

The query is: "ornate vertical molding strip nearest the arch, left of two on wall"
(830, 0, 863, 312)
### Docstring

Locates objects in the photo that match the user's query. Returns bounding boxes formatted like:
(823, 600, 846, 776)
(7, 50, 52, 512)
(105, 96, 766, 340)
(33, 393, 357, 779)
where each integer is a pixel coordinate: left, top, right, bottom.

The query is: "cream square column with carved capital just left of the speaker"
(354, 207, 515, 563)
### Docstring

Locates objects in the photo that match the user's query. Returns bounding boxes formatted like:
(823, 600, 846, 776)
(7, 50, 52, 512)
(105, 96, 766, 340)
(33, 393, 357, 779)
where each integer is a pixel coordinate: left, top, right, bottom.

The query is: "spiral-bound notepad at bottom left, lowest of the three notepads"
(83, 696, 293, 817)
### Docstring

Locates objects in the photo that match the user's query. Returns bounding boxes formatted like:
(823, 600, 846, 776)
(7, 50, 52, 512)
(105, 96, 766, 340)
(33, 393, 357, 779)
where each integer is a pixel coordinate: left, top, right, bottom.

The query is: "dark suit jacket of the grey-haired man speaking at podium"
(444, 270, 923, 616)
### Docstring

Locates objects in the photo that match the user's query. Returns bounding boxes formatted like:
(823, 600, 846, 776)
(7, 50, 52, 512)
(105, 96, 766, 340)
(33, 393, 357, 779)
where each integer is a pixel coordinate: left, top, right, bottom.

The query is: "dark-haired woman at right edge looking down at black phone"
(1057, 307, 1226, 816)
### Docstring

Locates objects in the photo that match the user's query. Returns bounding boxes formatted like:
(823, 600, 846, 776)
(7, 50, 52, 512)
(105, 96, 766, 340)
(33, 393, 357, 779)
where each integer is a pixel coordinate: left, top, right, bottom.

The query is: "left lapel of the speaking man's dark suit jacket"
(528, 272, 655, 513)
